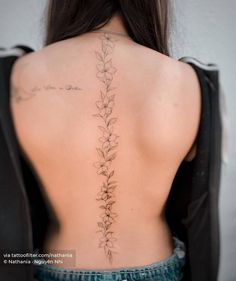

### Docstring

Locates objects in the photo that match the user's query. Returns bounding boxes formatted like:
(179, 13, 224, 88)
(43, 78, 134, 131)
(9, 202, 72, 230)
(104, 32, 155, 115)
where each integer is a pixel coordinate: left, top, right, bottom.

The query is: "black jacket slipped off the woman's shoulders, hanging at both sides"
(0, 46, 222, 281)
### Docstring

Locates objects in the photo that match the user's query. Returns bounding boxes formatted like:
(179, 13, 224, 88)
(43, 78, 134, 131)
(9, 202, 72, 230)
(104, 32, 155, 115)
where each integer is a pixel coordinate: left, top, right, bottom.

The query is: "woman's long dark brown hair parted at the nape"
(45, 0, 169, 55)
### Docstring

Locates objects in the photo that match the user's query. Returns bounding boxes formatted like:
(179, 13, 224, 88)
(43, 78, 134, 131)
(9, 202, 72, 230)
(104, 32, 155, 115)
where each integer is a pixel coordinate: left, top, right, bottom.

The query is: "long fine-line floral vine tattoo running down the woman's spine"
(93, 33, 119, 264)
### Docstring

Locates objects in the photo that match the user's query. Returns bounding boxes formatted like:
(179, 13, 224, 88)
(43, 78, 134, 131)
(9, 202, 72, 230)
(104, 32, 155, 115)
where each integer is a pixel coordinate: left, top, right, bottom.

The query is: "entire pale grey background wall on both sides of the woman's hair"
(0, 0, 236, 281)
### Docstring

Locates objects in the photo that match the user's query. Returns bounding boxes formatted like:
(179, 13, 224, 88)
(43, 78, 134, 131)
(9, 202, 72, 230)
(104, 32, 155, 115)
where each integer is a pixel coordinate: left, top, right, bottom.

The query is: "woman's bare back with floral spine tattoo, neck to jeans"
(10, 29, 200, 269)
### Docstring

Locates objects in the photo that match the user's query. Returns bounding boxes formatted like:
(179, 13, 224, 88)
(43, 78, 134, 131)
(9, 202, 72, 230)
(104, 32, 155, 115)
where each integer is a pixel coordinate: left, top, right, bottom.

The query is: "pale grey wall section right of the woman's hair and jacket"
(172, 0, 236, 281)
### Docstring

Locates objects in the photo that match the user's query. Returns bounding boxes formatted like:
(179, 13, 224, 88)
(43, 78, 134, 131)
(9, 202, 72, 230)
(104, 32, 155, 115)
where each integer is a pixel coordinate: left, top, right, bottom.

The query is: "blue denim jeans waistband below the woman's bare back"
(34, 236, 186, 281)
